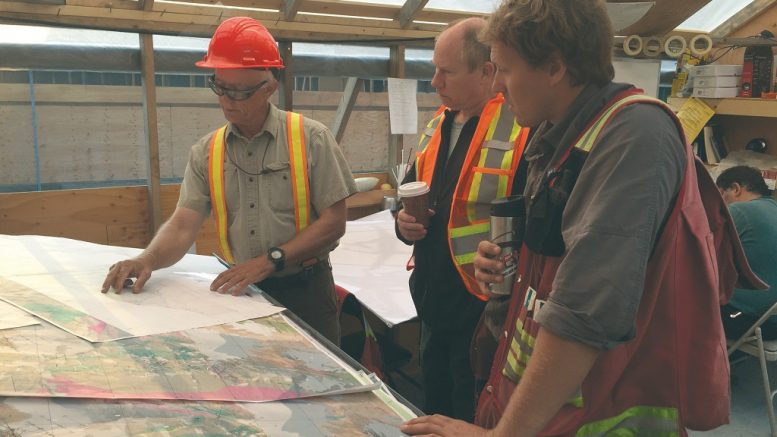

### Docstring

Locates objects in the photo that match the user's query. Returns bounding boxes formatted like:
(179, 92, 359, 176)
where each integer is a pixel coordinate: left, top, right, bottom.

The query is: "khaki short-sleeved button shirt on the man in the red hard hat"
(178, 104, 356, 275)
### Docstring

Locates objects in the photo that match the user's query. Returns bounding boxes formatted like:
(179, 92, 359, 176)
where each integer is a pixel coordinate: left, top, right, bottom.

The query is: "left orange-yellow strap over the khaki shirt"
(208, 126, 235, 264)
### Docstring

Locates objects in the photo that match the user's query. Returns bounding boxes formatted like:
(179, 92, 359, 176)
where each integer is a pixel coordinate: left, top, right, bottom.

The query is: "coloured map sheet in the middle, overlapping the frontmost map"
(0, 315, 379, 402)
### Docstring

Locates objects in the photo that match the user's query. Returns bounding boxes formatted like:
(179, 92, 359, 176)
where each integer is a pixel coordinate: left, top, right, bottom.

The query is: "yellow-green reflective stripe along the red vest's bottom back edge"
(575, 406, 680, 437)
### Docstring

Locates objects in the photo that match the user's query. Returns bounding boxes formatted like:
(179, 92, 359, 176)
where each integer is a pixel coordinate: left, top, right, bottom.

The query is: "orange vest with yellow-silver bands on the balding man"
(416, 94, 529, 300)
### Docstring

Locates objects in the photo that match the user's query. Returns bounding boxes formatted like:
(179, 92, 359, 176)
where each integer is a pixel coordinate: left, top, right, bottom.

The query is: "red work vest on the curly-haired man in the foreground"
(475, 92, 760, 437)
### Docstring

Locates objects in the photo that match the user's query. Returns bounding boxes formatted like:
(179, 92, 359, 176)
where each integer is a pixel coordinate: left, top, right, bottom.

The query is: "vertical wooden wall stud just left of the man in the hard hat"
(140, 33, 162, 235)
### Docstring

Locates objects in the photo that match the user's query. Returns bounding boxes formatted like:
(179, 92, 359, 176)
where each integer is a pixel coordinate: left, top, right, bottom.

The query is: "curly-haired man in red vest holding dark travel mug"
(402, 0, 762, 437)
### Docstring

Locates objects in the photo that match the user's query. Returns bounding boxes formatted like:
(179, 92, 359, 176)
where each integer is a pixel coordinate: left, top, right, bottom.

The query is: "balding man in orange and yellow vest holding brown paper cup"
(397, 18, 529, 420)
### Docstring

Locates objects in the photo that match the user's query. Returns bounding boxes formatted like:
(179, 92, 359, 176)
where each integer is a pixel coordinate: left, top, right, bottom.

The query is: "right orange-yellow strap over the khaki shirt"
(286, 112, 310, 233)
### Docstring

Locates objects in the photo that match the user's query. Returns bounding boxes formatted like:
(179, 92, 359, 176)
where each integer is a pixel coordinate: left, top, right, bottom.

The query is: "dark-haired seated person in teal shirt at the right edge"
(716, 165, 777, 340)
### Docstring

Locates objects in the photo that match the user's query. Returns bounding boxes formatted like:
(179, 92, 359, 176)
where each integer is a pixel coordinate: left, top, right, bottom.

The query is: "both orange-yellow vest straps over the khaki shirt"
(208, 112, 311, 264)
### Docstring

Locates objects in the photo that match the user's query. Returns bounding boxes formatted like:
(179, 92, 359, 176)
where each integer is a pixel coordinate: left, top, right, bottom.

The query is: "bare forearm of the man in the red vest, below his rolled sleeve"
(493, 328, 599, 437)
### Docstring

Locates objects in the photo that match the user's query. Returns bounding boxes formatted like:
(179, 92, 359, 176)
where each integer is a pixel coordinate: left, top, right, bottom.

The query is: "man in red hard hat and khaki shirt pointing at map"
(102, 17, 356, 344)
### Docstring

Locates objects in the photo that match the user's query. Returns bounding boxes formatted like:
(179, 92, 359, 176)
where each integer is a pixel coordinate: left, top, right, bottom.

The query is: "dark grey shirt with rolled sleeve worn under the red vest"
(526, 84, 686, 349)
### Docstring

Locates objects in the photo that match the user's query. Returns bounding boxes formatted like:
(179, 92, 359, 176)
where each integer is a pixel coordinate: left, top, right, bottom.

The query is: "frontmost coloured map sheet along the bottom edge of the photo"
(0, 384, 413, 437)
